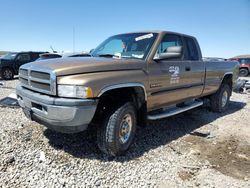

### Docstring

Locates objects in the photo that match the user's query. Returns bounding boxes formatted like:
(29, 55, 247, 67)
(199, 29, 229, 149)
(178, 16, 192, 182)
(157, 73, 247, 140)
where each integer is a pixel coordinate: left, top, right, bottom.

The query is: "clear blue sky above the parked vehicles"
(0, 0, 250, 58)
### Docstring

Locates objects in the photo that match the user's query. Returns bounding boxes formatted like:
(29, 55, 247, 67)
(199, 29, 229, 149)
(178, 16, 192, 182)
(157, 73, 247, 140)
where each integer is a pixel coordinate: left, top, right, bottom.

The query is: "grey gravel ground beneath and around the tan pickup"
(0, 77, 250, 187)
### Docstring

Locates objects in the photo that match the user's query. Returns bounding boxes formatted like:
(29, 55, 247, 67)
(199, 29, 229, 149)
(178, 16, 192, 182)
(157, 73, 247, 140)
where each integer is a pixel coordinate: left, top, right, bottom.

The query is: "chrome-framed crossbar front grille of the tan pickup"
(19, 64, 56, 95)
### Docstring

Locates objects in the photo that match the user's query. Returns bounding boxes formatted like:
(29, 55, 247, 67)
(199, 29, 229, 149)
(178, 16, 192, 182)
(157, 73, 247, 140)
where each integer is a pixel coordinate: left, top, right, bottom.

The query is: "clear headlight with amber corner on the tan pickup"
(57, 85, 93, 98)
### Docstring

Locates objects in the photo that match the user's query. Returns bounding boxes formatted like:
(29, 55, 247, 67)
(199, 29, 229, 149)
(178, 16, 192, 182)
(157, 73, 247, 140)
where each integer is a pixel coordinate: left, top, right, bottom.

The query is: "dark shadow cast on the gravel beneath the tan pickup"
(44, 101, 246, 162)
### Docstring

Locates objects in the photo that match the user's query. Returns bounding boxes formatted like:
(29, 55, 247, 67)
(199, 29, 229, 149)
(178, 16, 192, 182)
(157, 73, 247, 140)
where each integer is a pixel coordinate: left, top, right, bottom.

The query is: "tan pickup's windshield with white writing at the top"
(91, 33, 157, 59)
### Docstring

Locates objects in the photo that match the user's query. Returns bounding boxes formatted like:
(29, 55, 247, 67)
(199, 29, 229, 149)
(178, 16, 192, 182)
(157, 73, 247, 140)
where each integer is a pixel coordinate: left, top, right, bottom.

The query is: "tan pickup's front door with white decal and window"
(148, 34, 190, 110)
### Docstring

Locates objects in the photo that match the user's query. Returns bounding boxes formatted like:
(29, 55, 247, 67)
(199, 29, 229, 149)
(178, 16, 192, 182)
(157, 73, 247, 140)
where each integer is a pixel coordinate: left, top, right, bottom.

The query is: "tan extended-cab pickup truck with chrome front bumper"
(16, 31, 239, 156)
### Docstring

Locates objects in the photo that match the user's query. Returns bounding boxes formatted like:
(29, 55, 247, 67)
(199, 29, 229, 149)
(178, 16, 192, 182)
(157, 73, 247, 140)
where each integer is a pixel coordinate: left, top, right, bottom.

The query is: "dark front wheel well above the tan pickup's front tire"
(94, 87, 147, 125)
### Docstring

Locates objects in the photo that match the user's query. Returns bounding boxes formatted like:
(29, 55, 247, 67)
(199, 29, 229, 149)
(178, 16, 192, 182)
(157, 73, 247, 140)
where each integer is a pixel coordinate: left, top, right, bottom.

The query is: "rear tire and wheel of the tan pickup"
(210, 84, 231, 112)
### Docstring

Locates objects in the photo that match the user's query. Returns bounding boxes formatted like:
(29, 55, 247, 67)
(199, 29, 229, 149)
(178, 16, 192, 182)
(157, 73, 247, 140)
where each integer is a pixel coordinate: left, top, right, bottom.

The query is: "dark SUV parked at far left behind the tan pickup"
(0, 52, 46, 80)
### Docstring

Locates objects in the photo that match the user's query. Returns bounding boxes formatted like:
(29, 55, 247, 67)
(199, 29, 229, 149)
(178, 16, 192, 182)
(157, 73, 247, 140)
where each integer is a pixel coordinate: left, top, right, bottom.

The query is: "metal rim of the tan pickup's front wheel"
(119, 114, 133, 144)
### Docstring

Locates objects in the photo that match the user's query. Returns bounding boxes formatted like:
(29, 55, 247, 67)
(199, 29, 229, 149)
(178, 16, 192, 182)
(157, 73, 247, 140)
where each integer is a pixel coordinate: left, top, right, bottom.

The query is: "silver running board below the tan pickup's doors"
(147, 101, 203, 120)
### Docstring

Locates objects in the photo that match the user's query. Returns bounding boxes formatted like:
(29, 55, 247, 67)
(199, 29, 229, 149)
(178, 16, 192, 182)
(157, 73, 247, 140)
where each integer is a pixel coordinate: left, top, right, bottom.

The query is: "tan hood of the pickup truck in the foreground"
(29, 57, 146, 76)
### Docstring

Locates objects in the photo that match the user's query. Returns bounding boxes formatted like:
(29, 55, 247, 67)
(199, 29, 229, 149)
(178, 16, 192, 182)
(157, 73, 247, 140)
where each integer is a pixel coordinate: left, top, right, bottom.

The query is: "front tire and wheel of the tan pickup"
(97, 102, 136, 156)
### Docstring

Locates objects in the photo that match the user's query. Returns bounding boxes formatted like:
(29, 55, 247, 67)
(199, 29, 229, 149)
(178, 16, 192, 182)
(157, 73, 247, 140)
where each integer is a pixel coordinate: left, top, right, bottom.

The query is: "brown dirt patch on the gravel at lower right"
(185, 135, 250, 179)
